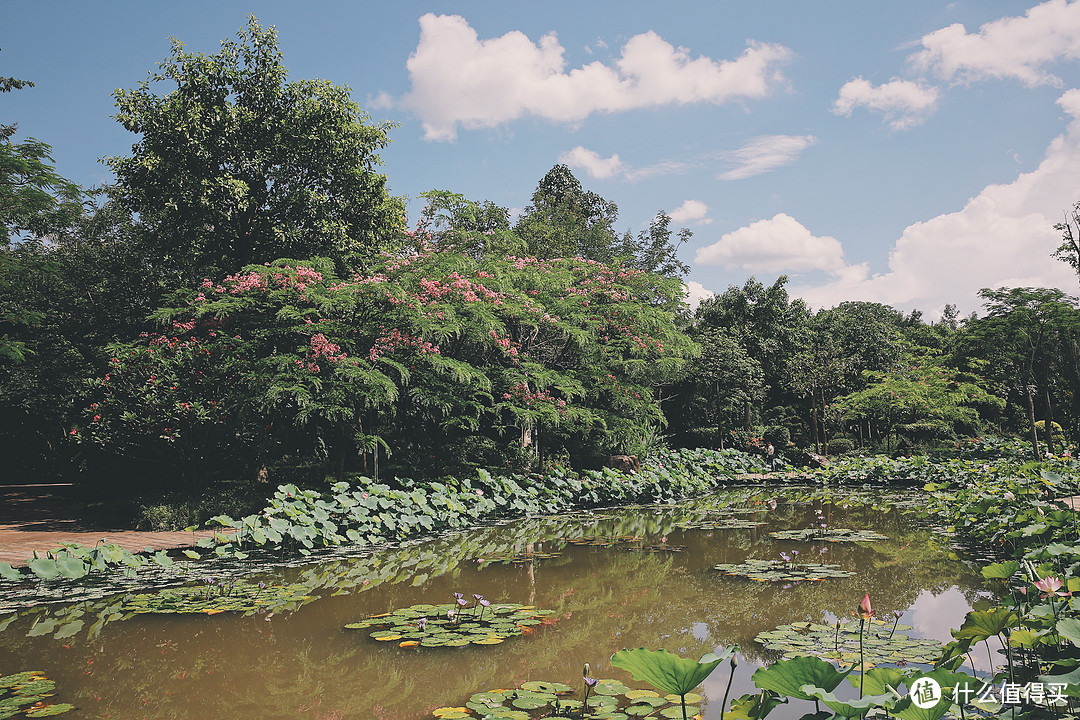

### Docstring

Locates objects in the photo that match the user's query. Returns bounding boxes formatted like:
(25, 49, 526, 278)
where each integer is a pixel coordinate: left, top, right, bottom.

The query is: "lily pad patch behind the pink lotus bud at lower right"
(754, 621, 943, 667)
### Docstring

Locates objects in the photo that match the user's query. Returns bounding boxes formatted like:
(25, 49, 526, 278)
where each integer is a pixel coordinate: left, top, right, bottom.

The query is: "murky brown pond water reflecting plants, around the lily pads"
(0, 488, 989, 720)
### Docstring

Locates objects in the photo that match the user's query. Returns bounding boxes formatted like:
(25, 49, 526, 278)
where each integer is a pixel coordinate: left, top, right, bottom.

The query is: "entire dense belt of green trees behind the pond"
(0, 19, 1080, 520)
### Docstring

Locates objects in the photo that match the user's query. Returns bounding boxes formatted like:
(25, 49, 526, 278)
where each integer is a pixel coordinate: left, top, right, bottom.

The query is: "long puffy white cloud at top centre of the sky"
(400, 13, 791, 140)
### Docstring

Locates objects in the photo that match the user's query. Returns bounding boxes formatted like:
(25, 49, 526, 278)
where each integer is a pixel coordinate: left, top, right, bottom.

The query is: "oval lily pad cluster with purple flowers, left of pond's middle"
(346, 602, 554, 648)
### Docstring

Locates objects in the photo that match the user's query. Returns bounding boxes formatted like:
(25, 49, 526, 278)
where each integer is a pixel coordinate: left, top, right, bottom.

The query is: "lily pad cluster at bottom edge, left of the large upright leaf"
(433, 679, 703, 720)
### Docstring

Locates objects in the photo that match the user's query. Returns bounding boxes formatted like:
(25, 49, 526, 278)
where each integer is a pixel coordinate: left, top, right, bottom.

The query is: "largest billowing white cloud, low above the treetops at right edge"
(786, 90, 1080, 314)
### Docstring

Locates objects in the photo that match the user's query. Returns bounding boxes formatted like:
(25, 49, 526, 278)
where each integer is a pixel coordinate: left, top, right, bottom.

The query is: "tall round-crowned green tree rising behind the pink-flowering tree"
(107, 16, 404, 284)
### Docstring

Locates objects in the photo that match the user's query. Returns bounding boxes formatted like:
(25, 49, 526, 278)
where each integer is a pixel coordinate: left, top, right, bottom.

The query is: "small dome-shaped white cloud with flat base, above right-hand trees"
(694, 213, 848, 274)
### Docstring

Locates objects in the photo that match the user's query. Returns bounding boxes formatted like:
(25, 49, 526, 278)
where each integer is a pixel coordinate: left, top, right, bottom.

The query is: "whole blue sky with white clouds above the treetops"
(6, 0, 1080, 317)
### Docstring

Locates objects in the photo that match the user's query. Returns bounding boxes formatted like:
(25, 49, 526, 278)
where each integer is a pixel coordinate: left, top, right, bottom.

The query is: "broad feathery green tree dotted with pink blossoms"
(82, 240, 692, 483)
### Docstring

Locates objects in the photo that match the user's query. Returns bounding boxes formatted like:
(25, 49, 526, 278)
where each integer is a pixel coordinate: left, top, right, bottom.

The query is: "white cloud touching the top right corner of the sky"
(908, 0, 1080, 86)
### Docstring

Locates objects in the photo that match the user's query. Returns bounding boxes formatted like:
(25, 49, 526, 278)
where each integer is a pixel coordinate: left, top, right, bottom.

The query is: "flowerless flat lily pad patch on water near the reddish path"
(120, 580, 315, 615)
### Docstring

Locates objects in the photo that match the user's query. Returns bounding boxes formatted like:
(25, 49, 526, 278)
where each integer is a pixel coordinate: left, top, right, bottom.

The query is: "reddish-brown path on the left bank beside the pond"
(0, 484, 224, 566)
